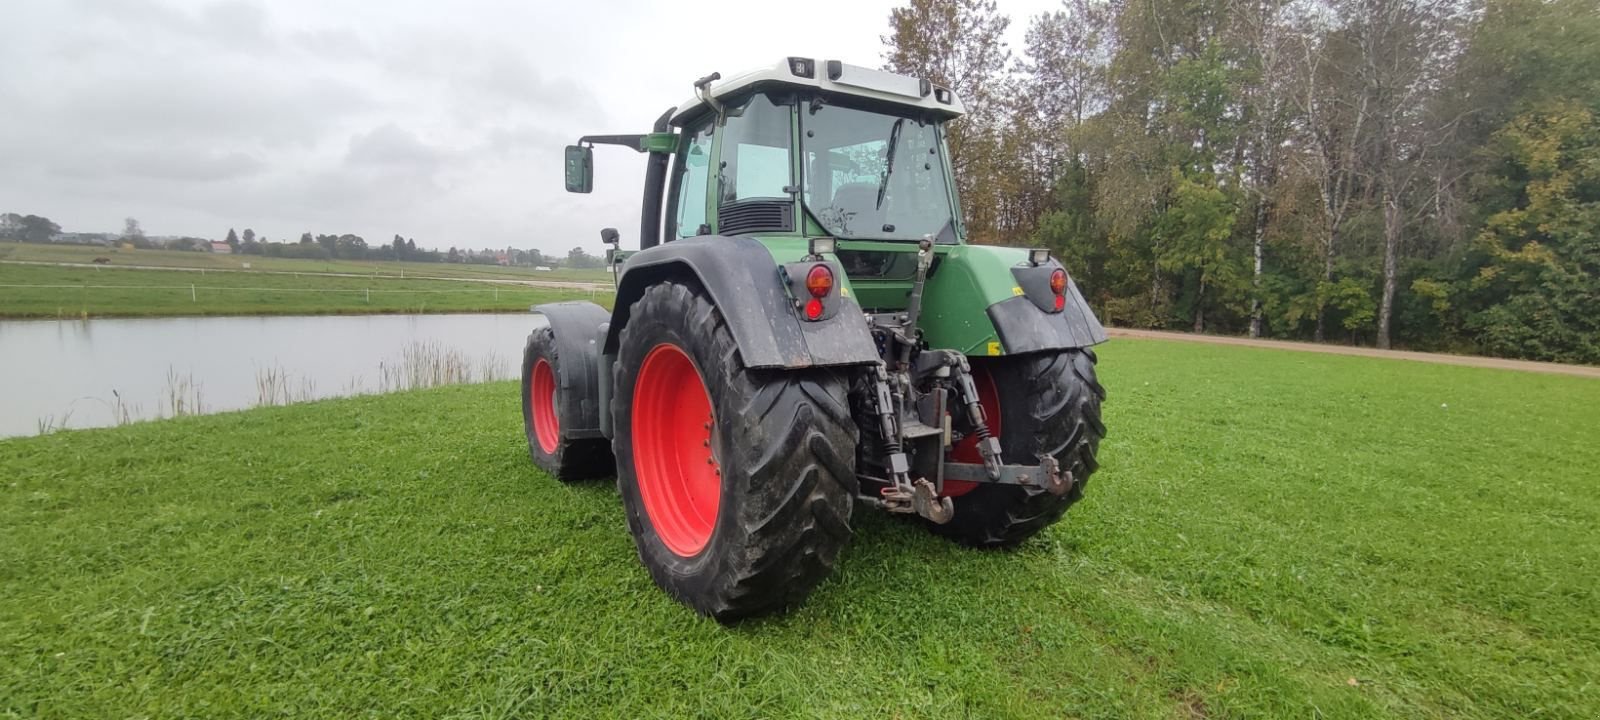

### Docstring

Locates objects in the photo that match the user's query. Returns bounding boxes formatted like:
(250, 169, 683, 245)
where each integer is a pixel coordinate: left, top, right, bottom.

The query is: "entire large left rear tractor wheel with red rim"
(611, 282, 856, 622)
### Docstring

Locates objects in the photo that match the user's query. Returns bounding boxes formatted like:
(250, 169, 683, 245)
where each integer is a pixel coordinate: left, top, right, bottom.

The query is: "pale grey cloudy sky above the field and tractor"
(0, 0, 1056, 253)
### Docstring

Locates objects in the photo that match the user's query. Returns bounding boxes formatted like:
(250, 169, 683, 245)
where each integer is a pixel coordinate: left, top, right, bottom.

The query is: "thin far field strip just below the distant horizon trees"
(0, 243, 611, 283)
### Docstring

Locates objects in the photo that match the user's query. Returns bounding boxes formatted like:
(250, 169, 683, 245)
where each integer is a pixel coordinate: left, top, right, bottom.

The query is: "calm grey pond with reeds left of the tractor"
(0, 314, 550, 437)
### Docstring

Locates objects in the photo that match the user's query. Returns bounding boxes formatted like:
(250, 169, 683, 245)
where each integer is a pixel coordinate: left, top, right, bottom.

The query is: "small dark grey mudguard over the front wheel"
(533, 301, 611, 438)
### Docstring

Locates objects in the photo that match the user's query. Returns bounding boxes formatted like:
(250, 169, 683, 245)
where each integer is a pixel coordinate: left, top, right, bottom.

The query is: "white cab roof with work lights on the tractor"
(672, 58, 966, 126)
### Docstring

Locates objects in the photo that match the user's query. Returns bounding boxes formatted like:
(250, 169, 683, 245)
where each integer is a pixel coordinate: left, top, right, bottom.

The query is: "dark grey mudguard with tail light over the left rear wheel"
(603, 235, 878, 368)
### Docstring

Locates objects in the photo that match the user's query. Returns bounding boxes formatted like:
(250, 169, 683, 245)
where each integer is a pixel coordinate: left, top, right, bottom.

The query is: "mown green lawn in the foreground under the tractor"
(0, 341, 1600, 718)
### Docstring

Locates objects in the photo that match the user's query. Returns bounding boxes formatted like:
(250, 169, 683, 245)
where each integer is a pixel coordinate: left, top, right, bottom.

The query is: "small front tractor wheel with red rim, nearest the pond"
(522, 326, 613, 480)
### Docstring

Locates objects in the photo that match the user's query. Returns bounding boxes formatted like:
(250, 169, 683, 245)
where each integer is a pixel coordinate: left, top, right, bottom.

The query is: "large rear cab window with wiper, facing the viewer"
(800, 99, 955, 242)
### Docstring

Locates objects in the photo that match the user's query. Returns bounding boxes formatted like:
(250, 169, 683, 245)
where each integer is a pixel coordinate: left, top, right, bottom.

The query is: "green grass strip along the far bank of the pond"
(0, 264, 611, 318)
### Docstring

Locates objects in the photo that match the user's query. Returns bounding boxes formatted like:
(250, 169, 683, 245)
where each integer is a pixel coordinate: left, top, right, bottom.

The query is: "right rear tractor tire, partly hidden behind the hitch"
(931, 347, 1106, 547)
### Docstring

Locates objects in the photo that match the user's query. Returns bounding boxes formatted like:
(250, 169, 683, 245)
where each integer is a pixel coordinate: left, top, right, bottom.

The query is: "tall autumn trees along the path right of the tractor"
(883, 0, 1600, 363)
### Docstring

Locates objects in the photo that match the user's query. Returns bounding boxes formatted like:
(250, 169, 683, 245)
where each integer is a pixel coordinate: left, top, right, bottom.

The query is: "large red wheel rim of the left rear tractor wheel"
(632, 344, 722, 557)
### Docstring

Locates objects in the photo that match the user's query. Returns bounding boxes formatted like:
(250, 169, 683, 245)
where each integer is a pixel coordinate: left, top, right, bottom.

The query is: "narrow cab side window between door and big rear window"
(717, 94, 792, 205)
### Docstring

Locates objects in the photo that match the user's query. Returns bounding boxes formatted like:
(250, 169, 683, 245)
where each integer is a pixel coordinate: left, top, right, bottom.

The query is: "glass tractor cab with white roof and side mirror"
(568, 58, 963, 248)
